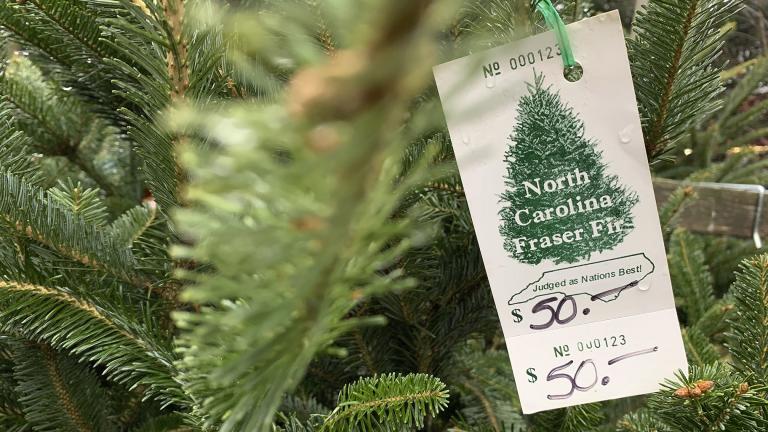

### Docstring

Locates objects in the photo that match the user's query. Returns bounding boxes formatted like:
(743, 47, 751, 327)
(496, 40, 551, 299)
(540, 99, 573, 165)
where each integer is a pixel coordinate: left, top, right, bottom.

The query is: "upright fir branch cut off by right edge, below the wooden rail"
(728, 254, 768, 383)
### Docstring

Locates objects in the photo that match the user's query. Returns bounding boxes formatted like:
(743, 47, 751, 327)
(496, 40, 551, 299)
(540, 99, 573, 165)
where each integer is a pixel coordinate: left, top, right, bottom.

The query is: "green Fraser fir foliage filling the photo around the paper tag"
(0, 0, 768, 432)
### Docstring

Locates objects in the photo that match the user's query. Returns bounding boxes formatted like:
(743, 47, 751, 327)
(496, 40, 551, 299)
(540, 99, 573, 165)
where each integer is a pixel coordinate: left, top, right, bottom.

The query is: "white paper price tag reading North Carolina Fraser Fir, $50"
(434, 11, 687, 414)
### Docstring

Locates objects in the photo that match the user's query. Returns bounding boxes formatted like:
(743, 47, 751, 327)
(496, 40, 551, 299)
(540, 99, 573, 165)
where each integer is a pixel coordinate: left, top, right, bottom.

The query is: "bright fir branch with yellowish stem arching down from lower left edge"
(0, 281, 184, 406)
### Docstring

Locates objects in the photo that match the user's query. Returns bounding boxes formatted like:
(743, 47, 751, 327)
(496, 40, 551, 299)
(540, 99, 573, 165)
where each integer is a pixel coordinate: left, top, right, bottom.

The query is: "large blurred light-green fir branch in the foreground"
(176, 0, 450, 432)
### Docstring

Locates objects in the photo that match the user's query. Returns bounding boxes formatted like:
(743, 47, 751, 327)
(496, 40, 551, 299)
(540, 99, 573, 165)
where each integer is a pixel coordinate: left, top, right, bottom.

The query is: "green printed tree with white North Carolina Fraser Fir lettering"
(499, 73, 638, 264)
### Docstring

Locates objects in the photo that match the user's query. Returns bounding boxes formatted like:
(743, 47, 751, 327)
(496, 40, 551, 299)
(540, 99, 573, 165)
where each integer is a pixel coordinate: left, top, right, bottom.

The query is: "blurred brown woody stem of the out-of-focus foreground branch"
(288, 0, 438, 322)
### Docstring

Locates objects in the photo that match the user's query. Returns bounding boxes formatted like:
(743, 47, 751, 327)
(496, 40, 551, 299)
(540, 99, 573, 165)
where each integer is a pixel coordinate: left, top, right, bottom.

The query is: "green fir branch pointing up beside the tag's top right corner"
(627, 0, 739, 160)
